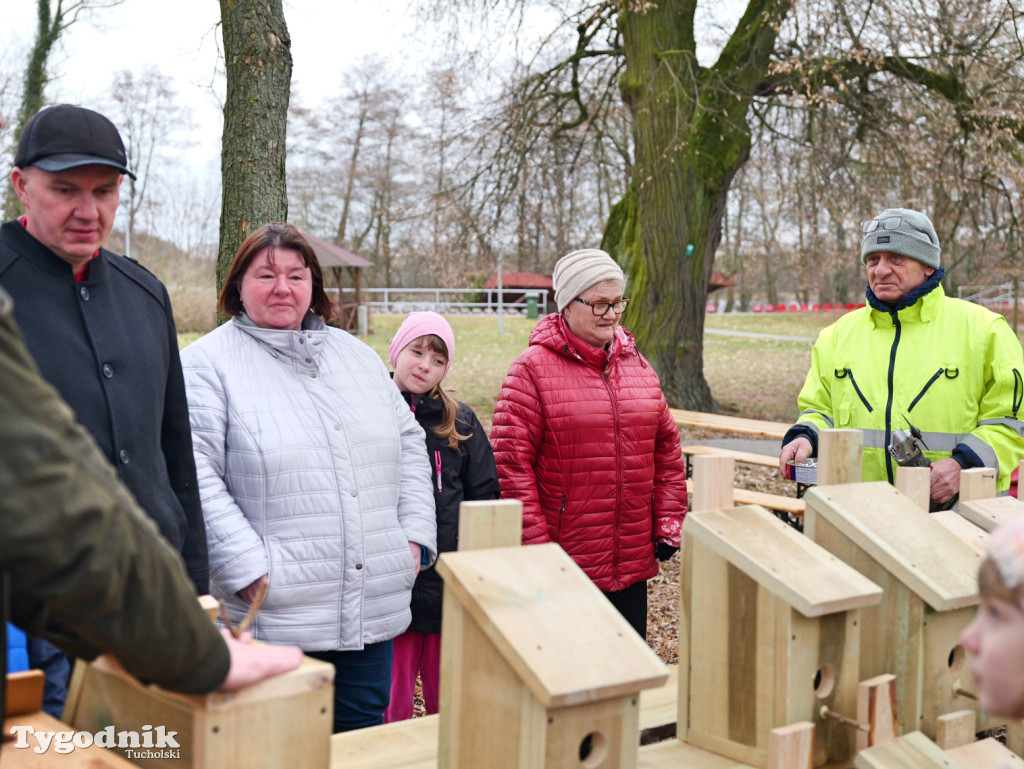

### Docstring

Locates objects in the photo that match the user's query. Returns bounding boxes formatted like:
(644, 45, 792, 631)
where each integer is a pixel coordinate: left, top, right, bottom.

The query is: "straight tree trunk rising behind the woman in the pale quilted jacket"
(217, 0, 292, 290)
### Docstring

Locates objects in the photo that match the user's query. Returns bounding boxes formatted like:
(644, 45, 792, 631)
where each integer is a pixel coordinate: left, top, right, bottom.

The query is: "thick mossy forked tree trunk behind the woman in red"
(604, 0, 791, 411)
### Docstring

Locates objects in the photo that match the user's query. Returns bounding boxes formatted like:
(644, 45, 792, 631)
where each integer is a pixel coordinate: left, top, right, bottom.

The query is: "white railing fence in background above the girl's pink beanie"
(326, 287, 550, 315)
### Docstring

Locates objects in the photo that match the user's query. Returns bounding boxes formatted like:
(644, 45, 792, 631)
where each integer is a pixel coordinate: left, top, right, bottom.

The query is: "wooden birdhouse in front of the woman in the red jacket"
(438, 544, 668, 769)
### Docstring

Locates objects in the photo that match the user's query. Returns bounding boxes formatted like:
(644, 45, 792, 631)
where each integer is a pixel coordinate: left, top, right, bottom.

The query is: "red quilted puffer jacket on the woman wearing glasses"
(490, 314, 686, 592)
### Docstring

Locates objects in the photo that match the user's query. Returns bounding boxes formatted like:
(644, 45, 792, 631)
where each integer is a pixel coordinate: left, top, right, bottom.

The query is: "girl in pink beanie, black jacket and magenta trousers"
(384, 312, 499, 723)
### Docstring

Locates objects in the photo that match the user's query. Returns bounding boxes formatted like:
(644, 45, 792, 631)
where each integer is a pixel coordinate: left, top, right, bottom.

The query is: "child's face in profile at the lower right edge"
(961, 596, 1024, 718)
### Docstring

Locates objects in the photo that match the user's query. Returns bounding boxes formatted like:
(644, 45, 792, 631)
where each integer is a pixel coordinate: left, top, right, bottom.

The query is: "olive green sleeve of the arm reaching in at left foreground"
(0, 289, 230, 693)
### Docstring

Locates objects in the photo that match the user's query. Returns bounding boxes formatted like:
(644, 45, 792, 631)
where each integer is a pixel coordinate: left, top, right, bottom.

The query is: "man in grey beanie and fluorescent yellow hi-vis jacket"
(779, 208, 1024, 505)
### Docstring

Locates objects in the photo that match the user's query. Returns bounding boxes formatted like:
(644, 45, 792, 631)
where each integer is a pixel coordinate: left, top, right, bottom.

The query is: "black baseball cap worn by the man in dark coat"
(14, 104, 135, 179)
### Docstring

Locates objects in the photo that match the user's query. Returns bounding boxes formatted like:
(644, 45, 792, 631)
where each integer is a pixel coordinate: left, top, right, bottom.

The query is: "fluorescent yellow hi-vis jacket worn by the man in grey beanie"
(786, 284, 1024, 493)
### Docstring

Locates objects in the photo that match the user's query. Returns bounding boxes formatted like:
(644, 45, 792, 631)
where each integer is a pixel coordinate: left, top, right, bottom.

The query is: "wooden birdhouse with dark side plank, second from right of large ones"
(677, 506, 882, 768)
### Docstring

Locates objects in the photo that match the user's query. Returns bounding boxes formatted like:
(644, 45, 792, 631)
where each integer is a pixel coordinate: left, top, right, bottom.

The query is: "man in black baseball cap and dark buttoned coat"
(0, 104, 209, 714)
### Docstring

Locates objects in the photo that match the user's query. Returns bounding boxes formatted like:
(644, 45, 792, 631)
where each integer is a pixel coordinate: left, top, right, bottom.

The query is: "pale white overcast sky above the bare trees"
(0, 0, 745, 185)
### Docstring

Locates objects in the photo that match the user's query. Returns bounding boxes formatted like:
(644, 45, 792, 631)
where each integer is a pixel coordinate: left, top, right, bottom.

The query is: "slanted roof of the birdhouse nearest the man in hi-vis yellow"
(804, 481, 982, 611)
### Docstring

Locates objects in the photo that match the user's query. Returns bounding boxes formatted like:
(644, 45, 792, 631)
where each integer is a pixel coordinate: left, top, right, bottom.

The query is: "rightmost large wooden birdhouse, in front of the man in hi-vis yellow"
(804, 481, 994, 739)
